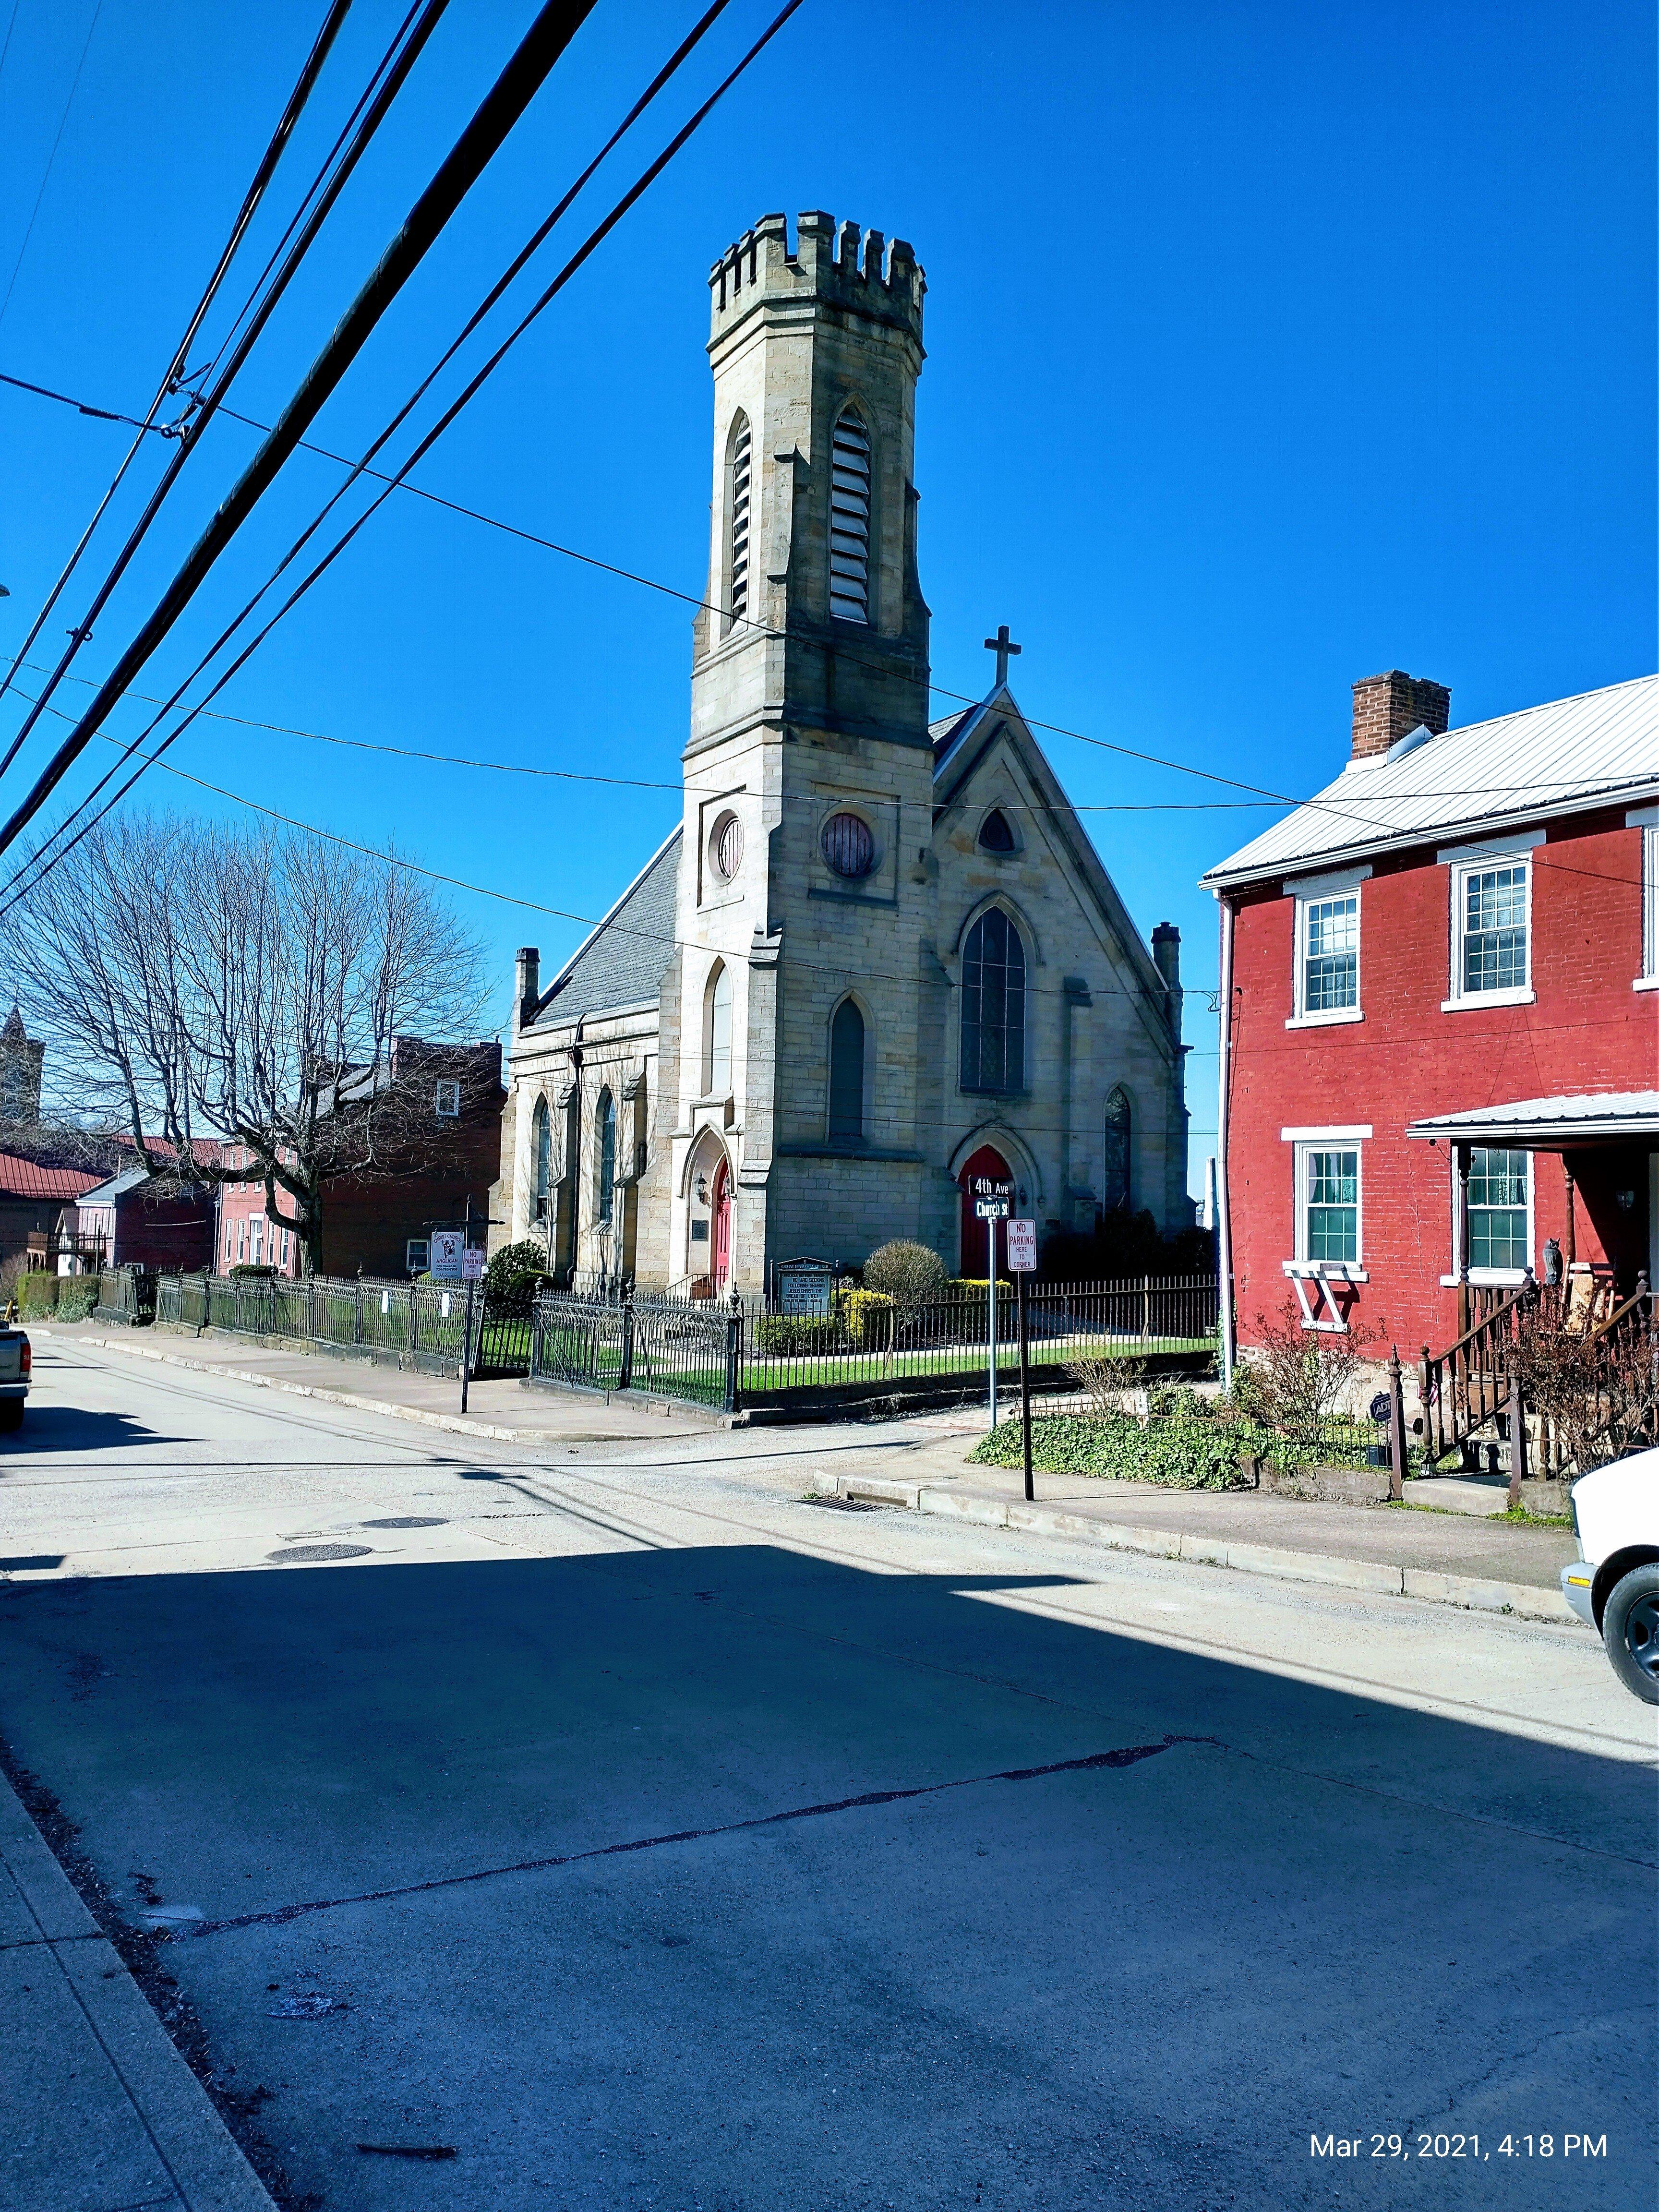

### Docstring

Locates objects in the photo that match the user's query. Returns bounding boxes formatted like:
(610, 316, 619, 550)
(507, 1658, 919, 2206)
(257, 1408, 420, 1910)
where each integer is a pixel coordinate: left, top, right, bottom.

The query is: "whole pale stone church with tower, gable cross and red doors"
(491, 212, 1192, 1296)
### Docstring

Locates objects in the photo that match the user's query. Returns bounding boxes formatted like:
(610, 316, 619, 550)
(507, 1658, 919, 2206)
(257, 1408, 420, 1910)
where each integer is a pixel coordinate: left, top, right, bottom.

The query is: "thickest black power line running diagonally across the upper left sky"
(0, 0, 606, 852)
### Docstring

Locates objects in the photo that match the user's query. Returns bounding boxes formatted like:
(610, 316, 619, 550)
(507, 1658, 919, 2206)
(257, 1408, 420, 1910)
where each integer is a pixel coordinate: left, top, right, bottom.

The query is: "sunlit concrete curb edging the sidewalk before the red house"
(823, 1476, 1577, 1623)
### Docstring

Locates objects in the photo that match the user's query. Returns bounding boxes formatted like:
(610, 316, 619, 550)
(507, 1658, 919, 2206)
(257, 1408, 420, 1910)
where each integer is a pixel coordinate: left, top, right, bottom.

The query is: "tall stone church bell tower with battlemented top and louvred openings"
(674, 212, 931, 1292)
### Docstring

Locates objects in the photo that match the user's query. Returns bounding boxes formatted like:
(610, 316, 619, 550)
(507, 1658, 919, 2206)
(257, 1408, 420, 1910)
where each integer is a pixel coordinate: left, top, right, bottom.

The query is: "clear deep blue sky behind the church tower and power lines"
(0, 0, 1655, 1186)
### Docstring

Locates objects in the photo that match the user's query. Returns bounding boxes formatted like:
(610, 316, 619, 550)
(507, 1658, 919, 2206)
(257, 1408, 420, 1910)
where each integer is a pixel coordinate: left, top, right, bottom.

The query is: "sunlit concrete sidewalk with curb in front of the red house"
(818, 1438, 1577, 1622)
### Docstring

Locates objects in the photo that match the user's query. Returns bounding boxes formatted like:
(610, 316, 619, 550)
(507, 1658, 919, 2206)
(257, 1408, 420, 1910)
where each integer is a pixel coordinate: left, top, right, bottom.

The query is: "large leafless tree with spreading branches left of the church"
(13, 812, 498, 1267)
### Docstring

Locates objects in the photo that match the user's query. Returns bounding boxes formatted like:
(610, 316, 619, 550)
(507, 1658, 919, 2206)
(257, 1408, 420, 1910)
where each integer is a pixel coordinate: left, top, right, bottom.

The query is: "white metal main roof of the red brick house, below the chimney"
(1201, 677, 1659, 889)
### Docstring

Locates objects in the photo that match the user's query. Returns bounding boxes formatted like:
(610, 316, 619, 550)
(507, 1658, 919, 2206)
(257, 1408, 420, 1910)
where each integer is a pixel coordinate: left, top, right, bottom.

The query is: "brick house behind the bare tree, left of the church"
(212, 1037, 506, 1278)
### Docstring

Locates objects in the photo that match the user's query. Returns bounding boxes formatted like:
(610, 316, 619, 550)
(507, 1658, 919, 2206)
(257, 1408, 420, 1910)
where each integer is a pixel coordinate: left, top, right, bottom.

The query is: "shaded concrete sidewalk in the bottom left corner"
(0, 1779, 274, 2212)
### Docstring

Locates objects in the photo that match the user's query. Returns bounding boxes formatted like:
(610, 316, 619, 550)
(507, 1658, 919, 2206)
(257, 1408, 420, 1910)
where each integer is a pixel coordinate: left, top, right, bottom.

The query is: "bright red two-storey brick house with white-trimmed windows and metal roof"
(1203, 670, 1659, 1358)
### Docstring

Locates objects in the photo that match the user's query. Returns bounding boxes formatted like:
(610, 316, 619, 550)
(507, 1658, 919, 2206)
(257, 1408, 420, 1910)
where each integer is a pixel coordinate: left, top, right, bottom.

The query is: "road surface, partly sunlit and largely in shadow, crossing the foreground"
(0, 1345, 1655, 2212)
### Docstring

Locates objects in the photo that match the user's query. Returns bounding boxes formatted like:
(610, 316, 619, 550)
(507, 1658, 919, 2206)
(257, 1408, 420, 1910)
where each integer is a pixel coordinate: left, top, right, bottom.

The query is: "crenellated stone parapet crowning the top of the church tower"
(708, 208, 927, 347)
